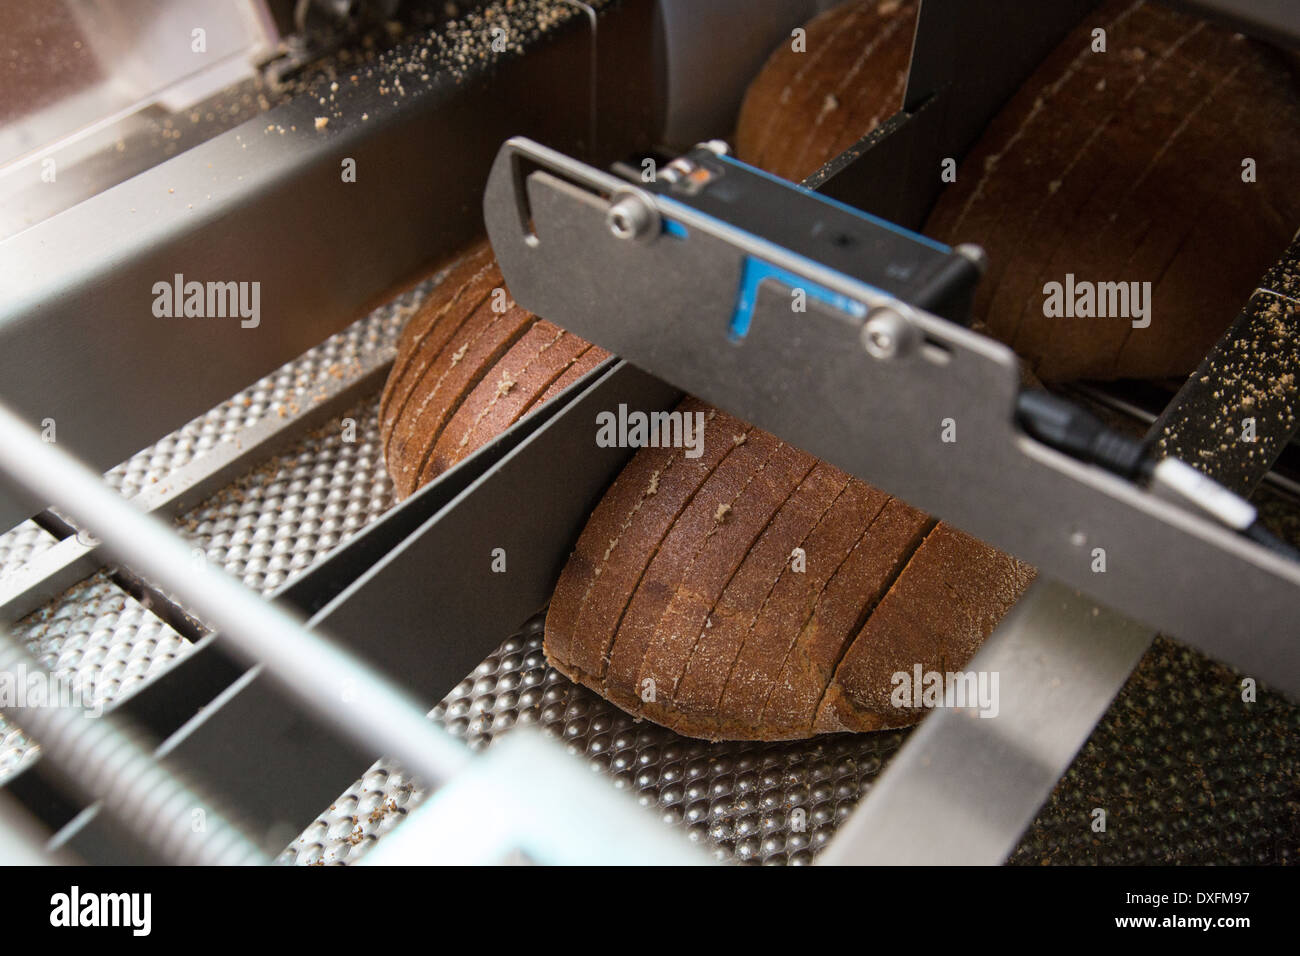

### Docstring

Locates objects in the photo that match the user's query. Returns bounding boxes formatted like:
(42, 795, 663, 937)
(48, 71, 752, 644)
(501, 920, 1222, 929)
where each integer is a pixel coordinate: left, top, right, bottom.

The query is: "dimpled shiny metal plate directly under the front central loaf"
(281, 615, 906, 864)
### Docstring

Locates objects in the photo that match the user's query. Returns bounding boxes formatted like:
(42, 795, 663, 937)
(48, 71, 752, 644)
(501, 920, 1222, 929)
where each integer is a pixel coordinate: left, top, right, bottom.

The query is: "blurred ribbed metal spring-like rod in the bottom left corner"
(0, 632, 267, 866)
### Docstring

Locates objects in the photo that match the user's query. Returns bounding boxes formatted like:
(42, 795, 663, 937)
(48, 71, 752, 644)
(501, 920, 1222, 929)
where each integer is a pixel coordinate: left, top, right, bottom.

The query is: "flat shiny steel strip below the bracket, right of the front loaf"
(818, 580, 1154, 865)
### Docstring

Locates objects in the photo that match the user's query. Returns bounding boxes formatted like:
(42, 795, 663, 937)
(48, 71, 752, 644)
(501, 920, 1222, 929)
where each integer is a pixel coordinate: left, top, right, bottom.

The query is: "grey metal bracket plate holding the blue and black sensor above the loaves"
(484, 138, 1300, 693)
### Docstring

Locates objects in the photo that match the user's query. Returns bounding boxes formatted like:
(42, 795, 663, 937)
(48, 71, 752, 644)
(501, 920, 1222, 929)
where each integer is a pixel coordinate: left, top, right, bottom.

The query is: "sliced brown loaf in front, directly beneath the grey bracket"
(545, 408, 1034, 740)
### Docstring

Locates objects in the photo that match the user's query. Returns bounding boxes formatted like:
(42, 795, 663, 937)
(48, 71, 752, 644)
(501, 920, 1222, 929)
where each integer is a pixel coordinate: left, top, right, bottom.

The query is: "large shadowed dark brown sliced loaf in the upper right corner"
(926, 0, 1300, 381)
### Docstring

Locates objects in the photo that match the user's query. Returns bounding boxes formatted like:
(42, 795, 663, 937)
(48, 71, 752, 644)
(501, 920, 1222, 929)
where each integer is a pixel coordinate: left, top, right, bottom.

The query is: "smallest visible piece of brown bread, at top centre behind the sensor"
(736, 0, 918, 182)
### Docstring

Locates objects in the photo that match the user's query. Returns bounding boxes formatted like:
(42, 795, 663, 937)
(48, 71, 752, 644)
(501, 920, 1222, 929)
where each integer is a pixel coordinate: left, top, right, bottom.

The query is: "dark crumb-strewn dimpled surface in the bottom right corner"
(1010, 637, 1300, 865)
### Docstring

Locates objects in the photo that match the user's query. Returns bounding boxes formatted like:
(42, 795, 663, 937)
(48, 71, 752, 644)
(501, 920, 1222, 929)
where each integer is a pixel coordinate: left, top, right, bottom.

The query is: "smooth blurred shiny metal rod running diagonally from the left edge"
(0, 406, 469, 784)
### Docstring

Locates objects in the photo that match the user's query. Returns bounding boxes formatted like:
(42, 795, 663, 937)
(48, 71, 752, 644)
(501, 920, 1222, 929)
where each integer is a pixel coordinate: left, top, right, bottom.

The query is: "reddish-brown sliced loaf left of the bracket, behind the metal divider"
(380, 242, 608, 498)
